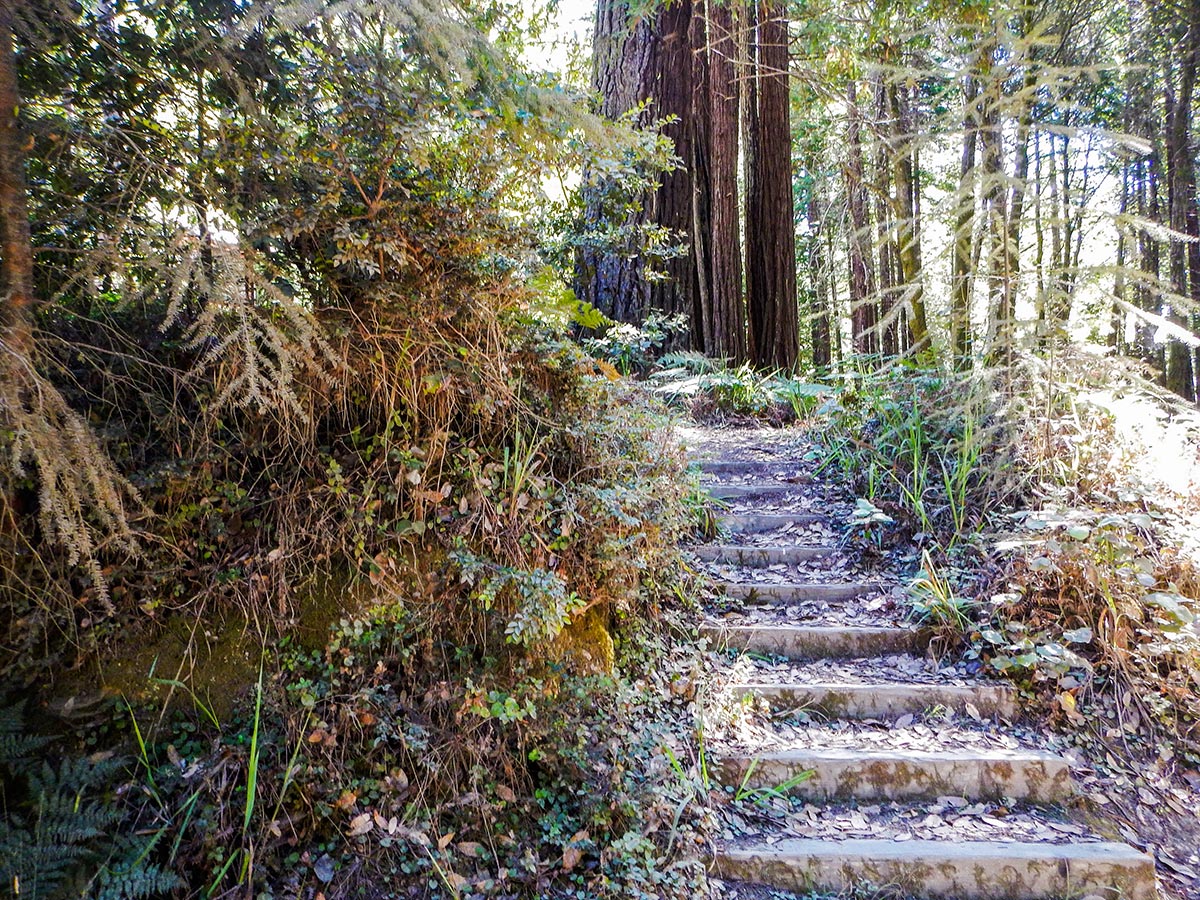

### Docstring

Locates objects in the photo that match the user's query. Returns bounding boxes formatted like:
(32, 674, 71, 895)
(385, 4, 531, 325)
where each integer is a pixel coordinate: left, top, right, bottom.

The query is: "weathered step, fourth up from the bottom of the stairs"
(700, 625, 929, 660)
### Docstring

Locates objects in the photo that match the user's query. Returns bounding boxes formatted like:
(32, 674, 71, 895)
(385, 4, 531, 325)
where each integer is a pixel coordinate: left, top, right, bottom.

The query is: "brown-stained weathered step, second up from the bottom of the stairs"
(721, 748, 1072, 803)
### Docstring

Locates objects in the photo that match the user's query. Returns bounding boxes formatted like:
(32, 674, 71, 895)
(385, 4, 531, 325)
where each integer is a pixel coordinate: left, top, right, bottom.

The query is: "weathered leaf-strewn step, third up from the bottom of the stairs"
(732, 682, 1016, 719)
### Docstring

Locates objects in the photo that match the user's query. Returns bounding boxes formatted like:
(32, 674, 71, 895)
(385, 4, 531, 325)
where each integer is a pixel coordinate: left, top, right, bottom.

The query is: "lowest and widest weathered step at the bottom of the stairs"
(716, 839, 1156, 900)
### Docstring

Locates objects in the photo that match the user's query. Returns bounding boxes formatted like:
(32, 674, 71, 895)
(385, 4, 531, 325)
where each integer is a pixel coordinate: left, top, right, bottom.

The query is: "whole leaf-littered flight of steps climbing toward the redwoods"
(680, 427, 1157, 900)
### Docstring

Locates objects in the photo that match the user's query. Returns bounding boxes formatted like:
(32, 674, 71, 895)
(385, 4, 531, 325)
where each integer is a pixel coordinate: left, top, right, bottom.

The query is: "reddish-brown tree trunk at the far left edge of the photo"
(0, 0, 34, 364)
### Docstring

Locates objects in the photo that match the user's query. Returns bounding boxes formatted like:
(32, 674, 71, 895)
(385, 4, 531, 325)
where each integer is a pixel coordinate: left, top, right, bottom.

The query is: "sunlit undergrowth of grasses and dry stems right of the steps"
(814, 352, 1200, 764)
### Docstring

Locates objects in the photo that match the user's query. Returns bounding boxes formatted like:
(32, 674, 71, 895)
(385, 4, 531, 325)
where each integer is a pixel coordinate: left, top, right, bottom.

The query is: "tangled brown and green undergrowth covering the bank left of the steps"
(0, 7, 703, 899)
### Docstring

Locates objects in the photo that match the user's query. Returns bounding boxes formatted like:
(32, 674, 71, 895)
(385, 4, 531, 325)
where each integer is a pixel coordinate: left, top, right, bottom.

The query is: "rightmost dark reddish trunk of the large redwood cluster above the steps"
(745, 0, 799, 371)
